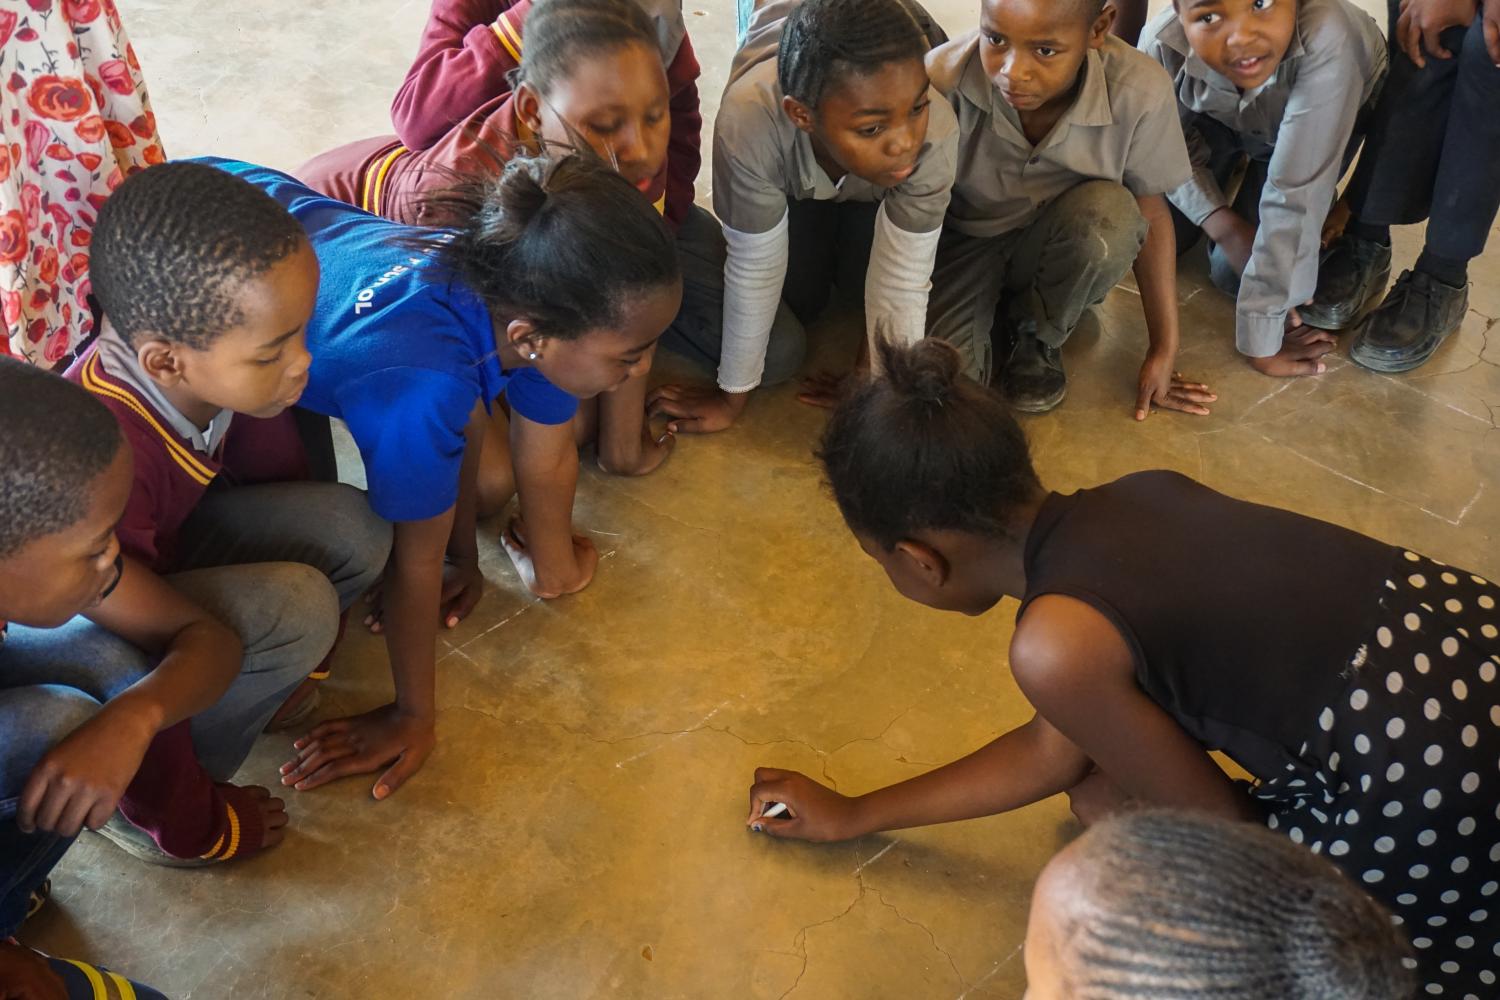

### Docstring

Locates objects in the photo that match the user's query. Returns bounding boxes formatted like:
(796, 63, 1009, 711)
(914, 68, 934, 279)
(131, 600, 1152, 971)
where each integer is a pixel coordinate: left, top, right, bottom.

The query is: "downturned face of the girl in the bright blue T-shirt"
(521, 282, 683, 399)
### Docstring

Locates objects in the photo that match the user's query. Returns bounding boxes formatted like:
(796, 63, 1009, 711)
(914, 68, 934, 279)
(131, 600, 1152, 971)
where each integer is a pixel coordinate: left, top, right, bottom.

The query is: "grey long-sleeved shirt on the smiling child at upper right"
(1140, 0, 1389, 357)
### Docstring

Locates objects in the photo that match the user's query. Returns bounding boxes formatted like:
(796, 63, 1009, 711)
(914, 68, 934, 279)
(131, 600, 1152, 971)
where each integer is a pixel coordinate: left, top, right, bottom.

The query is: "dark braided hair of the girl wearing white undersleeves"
(776, 0, 927, 108)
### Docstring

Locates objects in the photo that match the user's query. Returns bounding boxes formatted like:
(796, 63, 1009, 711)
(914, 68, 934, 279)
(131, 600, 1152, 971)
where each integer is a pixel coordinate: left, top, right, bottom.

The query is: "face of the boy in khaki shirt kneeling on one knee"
(980, 0, 1113, 112)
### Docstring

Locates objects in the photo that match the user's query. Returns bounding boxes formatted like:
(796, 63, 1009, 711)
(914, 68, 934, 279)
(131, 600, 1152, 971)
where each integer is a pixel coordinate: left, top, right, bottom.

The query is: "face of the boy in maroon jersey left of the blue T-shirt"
(140, 243, 318, 417)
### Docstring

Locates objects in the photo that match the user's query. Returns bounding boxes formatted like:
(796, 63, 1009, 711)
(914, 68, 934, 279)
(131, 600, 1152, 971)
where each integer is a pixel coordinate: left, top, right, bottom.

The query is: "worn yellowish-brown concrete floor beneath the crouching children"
(27, 0, 1500, 1000)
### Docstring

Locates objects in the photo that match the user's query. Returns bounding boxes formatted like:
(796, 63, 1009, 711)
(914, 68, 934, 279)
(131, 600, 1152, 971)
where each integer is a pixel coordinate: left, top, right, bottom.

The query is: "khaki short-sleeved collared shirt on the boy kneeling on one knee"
(927, 30, 1193, 237)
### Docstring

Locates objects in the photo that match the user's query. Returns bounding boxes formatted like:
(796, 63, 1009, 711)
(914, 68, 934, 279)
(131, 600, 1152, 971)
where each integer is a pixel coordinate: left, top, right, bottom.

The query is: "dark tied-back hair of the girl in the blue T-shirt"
(413, 151, 680, 339)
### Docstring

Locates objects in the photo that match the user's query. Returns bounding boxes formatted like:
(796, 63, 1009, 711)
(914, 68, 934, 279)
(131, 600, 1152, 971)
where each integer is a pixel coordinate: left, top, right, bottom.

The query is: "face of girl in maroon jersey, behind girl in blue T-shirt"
(516, 42, 672, 192)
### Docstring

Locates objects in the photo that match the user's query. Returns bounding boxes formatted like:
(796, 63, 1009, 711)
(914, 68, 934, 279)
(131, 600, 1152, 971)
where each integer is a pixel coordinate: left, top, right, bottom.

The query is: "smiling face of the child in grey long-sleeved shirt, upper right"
(1176, 0, 1298, 90)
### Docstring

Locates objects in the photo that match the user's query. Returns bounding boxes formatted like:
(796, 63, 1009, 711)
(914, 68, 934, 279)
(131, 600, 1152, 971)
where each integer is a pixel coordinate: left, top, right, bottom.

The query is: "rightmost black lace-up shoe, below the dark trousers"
(1349, 271, 1469, 372)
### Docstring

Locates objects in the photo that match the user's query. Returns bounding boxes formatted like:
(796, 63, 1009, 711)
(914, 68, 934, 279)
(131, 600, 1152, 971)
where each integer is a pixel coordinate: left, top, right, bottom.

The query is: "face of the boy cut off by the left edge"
(0, 441, 132, 628)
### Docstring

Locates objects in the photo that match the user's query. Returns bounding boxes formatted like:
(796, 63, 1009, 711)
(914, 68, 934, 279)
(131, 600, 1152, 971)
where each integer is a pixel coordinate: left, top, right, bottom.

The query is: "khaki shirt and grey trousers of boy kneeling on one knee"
(927, 30, 1191, 381)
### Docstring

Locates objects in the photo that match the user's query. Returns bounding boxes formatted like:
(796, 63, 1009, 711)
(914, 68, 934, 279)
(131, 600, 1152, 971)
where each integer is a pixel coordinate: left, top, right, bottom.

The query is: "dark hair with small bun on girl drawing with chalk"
(818, 340, 1041, 549)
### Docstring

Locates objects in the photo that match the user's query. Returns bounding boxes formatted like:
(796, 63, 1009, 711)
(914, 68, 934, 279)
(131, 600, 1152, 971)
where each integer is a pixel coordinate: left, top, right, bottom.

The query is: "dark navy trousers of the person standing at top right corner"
(1349, 0, 1500, 261)
